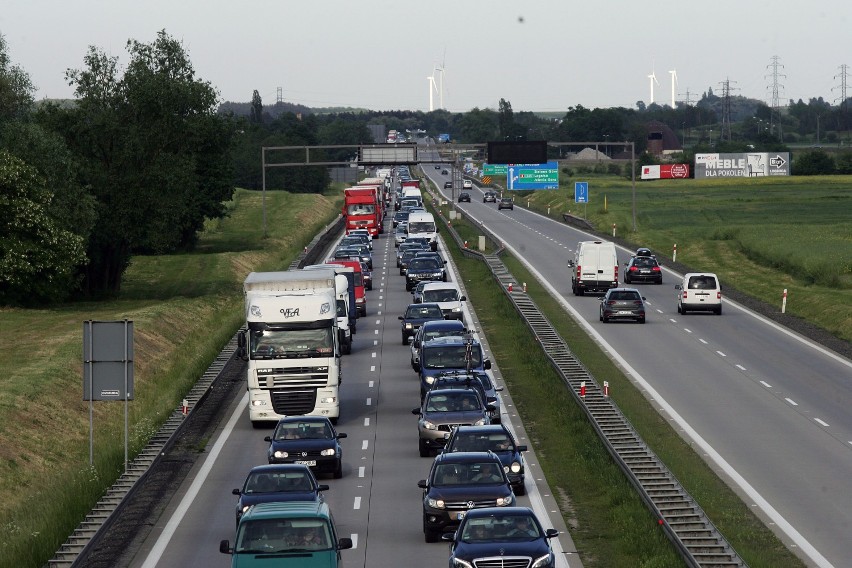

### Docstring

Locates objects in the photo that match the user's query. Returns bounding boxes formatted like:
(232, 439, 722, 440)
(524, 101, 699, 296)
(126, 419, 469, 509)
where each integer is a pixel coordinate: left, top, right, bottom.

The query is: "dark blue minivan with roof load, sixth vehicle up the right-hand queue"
(420, 335, 491, 400)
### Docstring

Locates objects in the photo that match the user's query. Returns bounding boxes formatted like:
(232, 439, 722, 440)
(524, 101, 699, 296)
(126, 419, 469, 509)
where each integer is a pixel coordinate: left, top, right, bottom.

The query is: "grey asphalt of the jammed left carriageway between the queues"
(130, 187, 582, 568)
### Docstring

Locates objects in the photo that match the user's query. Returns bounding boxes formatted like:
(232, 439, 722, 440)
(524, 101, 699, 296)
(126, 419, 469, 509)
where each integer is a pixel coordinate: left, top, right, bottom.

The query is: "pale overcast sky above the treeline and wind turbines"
(0, 0, 852, 112)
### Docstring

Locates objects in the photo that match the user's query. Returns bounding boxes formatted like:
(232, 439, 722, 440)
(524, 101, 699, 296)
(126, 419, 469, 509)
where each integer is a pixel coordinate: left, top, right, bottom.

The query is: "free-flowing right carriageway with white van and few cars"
(426, 160, 852, 567)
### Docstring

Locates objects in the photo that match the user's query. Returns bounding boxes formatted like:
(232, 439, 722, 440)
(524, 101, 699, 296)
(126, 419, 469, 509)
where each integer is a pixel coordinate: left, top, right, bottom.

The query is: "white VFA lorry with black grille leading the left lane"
(237, 270, 342, 428)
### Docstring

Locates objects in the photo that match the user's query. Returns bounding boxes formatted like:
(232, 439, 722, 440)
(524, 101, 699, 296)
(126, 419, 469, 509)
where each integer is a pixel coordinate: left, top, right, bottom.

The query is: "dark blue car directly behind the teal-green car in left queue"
(232, 463, 328, 523)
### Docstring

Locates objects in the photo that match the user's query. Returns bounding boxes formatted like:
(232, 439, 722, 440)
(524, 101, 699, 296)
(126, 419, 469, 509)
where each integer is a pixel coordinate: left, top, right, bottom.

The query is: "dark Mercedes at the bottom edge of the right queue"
(443, 507, 559, 568)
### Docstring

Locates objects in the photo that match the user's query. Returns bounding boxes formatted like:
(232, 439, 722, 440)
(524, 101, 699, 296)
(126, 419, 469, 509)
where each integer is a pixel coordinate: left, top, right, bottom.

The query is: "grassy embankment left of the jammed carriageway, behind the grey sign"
(0, 190, 339, 568)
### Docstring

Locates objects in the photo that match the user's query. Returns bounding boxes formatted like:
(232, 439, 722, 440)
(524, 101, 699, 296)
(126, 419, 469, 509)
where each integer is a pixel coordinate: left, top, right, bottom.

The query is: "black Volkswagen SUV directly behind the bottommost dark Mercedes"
(417, 452, 515, 542)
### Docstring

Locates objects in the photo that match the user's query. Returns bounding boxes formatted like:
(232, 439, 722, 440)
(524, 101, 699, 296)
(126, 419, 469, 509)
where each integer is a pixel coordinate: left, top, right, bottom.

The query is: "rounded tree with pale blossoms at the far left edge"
(0, 150, 86, 306)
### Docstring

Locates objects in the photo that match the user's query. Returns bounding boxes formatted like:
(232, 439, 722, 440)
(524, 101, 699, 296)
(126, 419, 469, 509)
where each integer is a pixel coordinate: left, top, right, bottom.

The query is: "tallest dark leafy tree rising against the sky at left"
(58, 31, 234, 293)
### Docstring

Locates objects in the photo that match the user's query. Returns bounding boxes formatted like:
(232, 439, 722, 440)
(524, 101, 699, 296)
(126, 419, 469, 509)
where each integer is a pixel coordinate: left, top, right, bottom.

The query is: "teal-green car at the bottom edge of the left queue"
(219, 501, 352, 568)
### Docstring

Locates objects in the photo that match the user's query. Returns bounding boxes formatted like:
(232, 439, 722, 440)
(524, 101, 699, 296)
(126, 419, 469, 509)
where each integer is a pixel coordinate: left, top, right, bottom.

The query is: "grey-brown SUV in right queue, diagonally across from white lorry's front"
(411, 388, 492, 458)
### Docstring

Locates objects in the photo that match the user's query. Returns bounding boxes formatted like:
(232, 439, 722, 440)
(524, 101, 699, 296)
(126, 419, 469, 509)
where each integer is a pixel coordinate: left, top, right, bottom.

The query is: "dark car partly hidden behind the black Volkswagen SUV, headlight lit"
(444, 424, 527, 495)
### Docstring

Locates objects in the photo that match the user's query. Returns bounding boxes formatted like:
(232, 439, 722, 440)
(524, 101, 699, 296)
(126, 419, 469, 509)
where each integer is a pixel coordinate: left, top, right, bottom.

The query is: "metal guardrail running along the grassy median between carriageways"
(432, 192, 747, 568)
